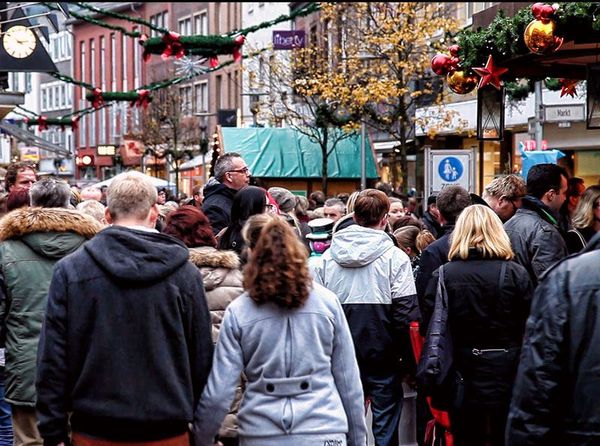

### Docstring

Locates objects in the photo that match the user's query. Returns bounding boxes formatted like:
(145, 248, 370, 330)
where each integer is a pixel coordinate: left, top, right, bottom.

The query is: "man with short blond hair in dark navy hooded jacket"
(36, 172, 213, 446)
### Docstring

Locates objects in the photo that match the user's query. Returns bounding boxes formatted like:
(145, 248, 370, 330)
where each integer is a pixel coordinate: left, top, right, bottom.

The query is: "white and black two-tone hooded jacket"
(313, 225, 420, 372)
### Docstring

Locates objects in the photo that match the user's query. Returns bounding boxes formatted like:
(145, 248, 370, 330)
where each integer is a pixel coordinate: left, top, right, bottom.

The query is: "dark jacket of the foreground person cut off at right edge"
(506, 234, 600, 446)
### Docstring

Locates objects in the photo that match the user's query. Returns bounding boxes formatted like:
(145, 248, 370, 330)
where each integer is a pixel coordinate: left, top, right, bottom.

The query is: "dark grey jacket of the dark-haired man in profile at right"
(504, 195, 567, 285)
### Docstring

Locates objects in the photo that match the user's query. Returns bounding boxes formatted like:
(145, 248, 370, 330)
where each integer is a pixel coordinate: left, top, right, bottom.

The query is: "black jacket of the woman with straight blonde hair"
(421, 250, 533, 408)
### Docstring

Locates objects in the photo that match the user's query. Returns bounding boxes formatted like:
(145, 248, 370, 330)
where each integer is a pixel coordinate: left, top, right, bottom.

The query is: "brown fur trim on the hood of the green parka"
(0, 207, 102, 241)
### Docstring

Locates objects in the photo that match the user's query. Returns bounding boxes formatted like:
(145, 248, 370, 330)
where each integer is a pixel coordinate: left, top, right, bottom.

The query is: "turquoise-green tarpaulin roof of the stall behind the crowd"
(221, 127, 378, 179)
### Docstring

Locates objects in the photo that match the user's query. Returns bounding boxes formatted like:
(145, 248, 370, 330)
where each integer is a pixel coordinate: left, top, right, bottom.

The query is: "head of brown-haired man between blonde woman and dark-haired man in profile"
(483, 174, 527, 222)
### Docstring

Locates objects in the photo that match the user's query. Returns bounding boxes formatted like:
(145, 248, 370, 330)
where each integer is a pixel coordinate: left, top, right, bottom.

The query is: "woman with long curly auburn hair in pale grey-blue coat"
(194, 214, 367, 446)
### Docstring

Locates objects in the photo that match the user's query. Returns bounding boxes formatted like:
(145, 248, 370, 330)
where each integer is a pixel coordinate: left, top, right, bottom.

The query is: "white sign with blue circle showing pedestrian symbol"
(425, 148, 475, 196)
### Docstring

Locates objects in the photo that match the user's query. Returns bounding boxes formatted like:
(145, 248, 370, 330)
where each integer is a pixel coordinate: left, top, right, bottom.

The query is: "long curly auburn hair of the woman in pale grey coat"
(243, 214, 312, 308)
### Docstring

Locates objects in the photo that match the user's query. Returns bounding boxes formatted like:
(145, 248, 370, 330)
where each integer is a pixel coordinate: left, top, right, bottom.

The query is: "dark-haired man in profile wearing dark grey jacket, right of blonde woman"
(504, 164, 568, 285)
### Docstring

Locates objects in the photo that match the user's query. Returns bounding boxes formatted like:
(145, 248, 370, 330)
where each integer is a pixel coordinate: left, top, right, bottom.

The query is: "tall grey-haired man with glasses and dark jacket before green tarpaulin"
(202, 152, 250, 234)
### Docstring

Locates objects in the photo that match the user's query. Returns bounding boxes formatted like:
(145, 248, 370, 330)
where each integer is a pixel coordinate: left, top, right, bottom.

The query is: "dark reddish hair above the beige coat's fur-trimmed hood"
(162, 205, 217, 248)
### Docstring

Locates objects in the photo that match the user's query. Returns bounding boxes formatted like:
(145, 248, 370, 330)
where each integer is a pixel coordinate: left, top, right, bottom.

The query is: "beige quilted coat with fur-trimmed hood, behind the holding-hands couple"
(190, 246, 244, 437)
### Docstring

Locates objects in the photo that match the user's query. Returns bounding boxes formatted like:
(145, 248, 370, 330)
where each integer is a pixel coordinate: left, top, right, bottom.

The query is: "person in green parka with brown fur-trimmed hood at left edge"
(0, 178, 101, 445)
